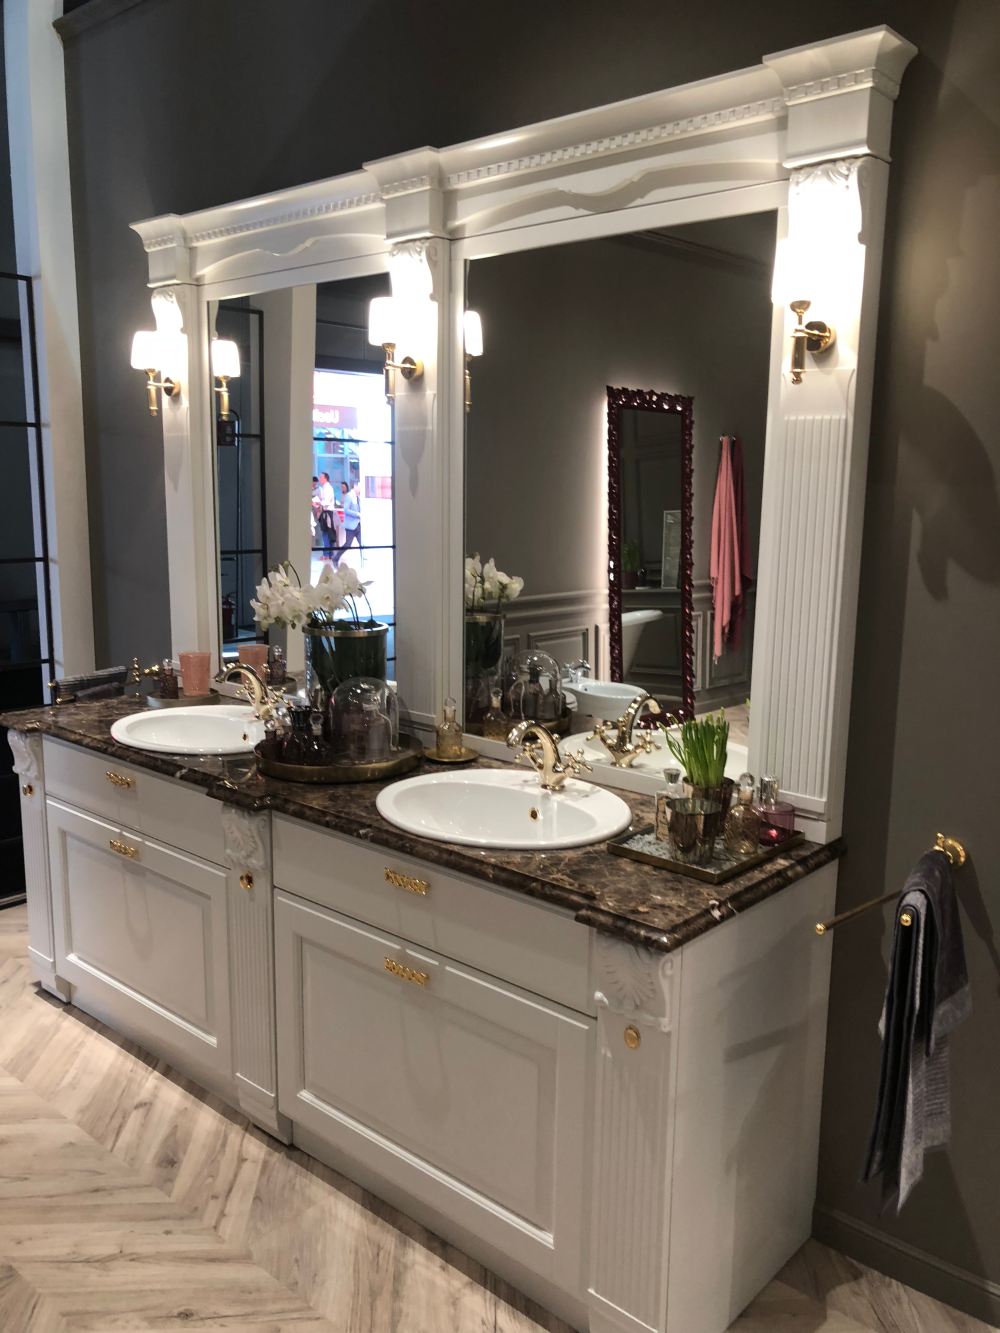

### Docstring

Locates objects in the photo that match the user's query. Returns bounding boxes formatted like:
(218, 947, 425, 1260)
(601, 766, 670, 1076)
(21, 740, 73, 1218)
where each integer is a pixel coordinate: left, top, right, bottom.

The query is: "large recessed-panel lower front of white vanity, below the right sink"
(275, 892, 595, 1289)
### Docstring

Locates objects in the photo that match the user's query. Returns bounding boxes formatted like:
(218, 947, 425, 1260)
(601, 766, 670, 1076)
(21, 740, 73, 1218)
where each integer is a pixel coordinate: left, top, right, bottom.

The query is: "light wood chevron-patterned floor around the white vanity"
(0, 908, 989, 1333)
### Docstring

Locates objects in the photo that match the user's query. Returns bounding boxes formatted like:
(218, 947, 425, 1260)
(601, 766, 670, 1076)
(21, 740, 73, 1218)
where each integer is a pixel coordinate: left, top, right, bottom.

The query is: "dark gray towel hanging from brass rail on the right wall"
(863, 852, 972, 1212)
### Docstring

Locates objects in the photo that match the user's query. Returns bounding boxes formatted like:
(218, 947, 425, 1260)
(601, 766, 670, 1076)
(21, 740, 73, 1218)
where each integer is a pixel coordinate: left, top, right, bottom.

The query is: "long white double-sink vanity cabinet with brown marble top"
(4, 700, 840, 1333)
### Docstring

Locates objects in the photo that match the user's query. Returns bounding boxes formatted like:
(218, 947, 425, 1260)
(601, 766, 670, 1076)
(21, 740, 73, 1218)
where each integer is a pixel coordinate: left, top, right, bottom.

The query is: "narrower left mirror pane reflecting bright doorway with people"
(209, 273, 396, 676)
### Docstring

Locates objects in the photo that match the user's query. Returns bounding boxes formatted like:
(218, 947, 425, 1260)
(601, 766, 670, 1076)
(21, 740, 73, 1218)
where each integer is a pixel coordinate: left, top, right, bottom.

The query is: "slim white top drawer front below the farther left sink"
(43, 736, 224, 865)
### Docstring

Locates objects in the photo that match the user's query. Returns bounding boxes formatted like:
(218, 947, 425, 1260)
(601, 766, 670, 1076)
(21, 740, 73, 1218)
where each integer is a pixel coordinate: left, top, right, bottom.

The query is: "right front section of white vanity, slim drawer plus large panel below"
(273, 816, 596, 1322)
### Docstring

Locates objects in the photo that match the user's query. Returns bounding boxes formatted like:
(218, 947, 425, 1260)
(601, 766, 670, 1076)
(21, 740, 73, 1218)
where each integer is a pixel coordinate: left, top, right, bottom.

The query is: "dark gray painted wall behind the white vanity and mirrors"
(60, 0, 1000, 1322)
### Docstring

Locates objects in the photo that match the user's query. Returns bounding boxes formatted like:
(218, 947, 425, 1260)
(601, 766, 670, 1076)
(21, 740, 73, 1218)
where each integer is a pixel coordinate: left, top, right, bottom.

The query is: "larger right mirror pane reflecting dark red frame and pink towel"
(465, 212, 776, 762)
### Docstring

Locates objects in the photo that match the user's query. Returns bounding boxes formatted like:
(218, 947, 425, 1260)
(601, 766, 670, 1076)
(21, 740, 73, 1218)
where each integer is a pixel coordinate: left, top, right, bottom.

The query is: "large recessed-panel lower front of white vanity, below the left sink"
(48, 800, 229, 1082)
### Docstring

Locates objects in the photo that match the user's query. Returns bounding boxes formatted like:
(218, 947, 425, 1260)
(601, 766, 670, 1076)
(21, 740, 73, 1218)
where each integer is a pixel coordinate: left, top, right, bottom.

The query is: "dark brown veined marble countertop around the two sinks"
(0, 698, 844, 953)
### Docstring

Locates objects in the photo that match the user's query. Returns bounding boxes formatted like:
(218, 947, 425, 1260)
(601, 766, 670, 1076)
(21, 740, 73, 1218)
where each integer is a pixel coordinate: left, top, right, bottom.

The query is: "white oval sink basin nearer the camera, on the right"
(375, 769, 632, 852)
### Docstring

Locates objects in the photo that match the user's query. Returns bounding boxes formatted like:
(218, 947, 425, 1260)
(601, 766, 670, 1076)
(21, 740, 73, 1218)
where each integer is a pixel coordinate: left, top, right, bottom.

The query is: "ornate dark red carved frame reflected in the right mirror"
(608, 384, 695, 721)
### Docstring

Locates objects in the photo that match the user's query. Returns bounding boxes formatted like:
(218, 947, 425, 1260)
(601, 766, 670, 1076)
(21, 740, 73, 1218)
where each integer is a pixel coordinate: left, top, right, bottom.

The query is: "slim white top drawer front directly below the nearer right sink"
(272, 816, 595, 1013)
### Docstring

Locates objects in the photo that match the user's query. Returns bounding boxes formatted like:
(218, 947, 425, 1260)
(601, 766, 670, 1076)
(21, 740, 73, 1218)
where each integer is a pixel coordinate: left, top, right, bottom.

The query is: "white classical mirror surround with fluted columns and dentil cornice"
(131, 24, 916, 841)
